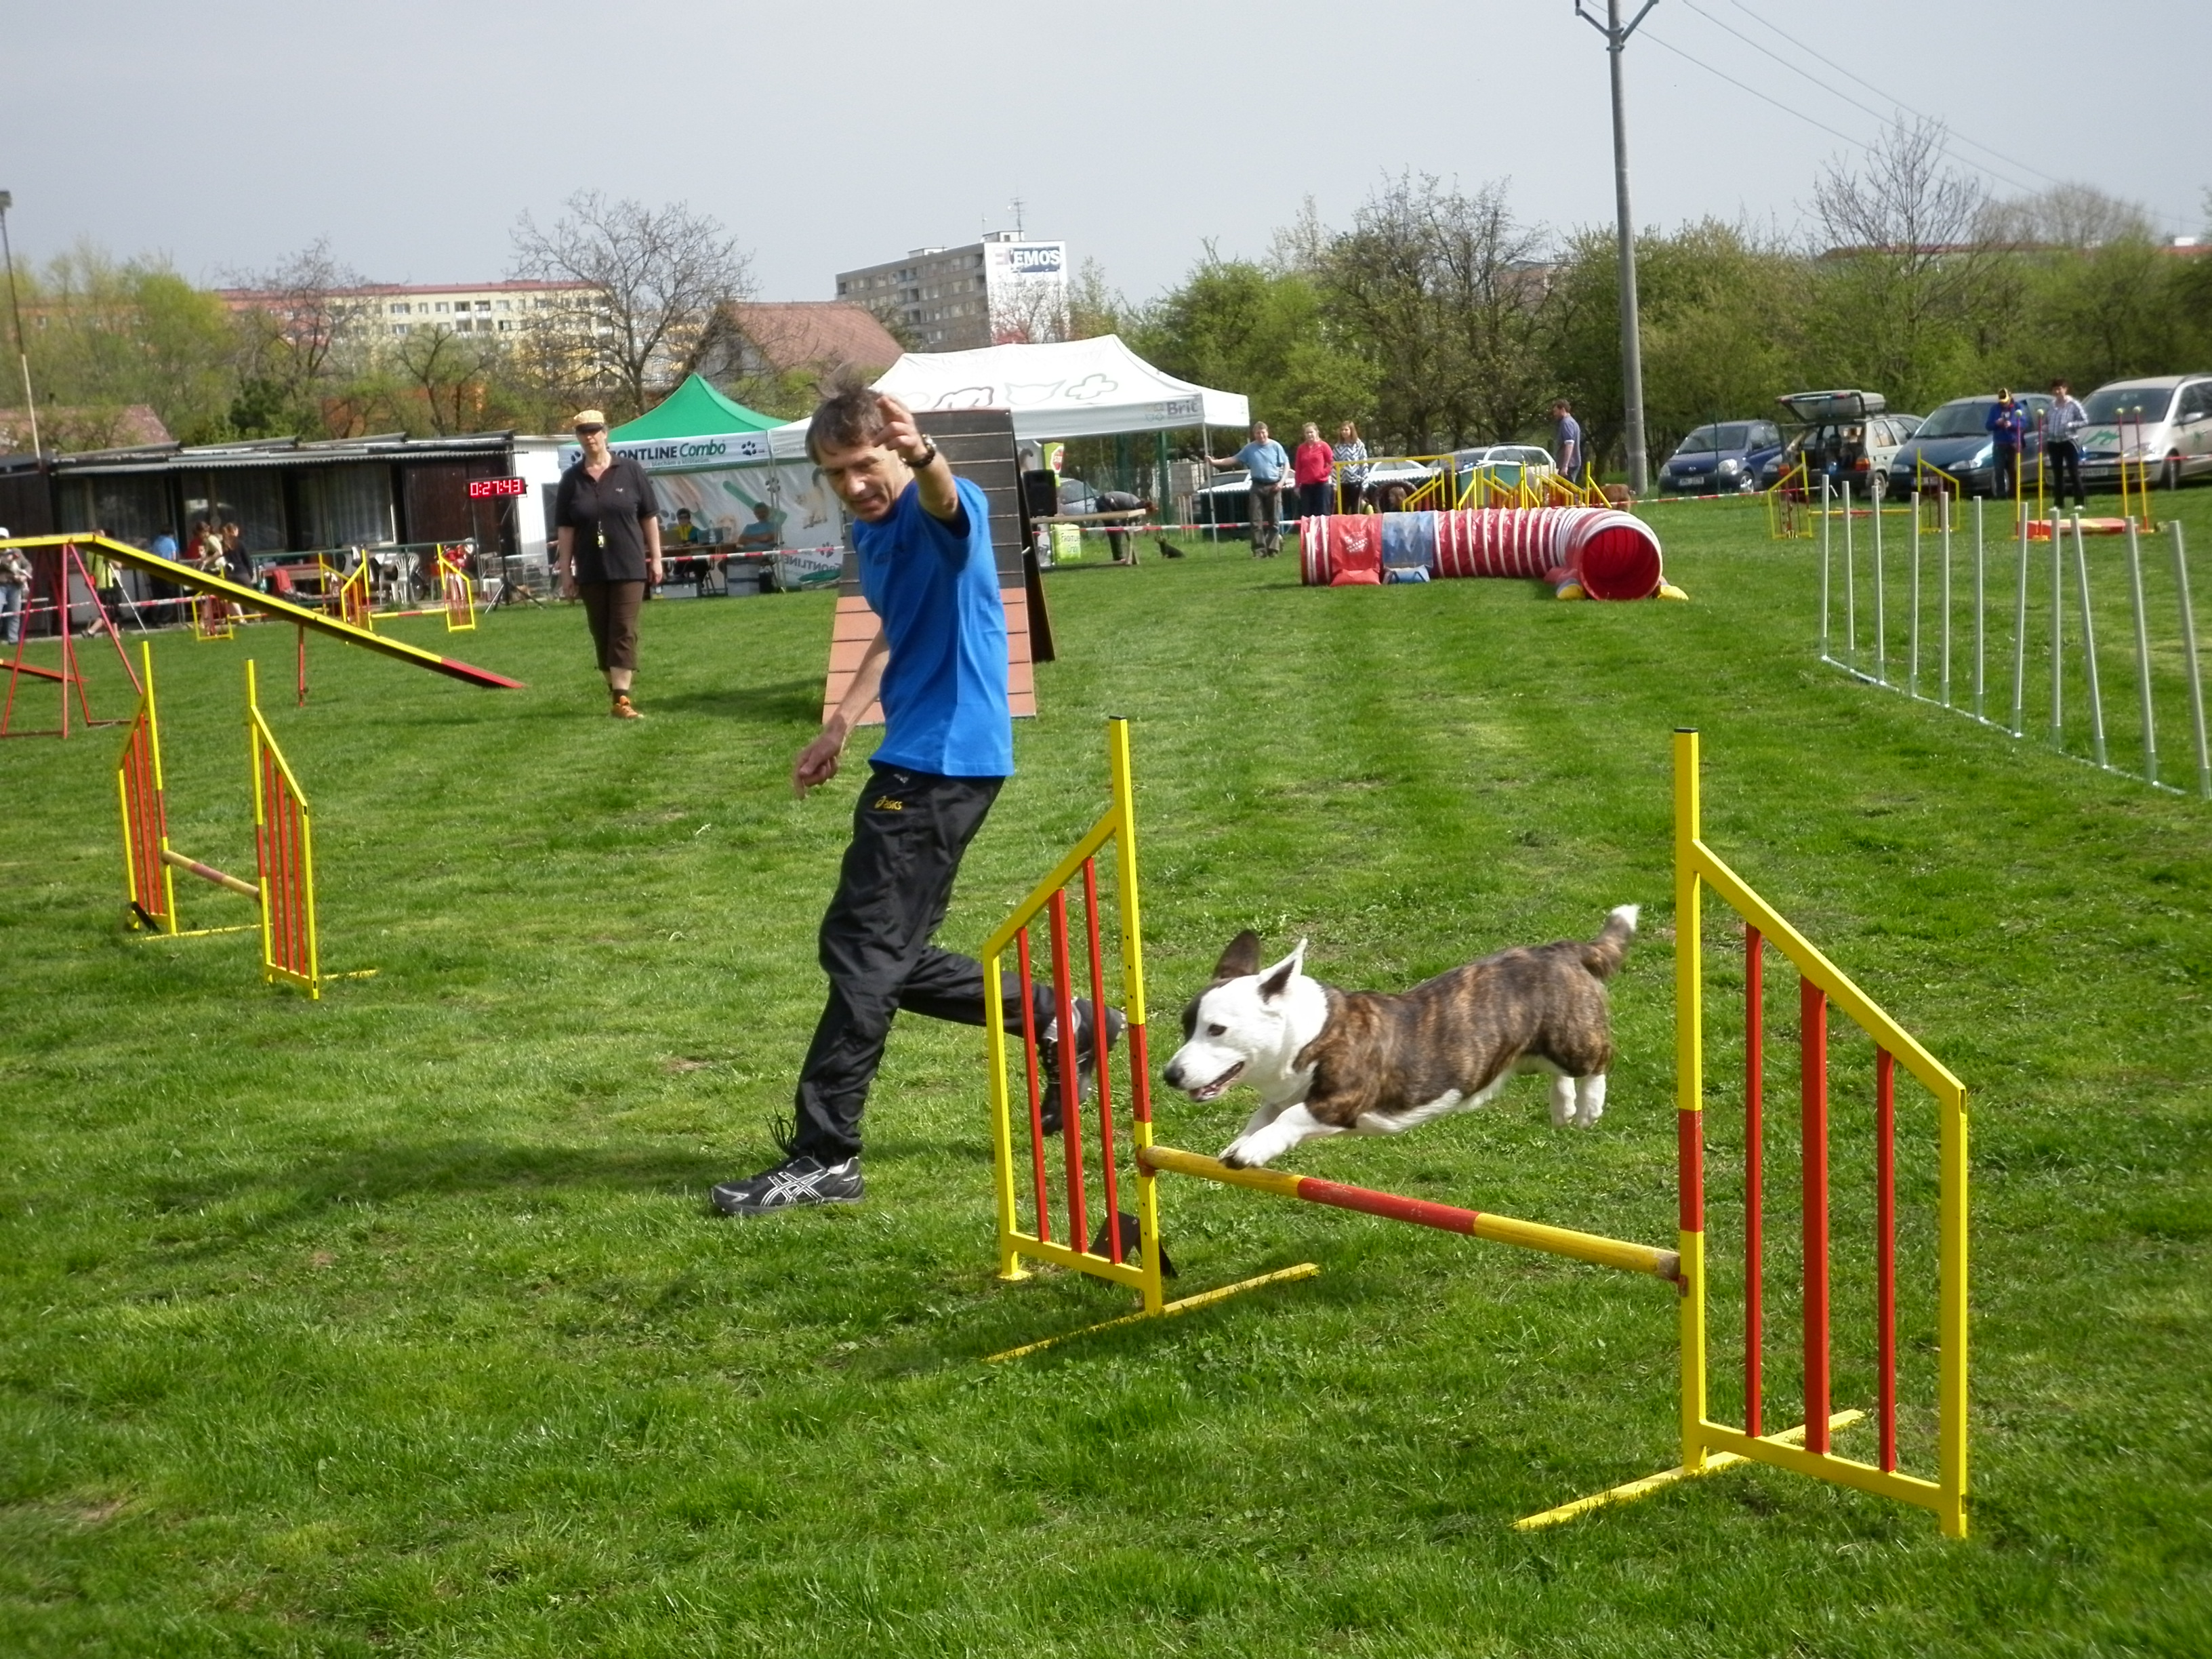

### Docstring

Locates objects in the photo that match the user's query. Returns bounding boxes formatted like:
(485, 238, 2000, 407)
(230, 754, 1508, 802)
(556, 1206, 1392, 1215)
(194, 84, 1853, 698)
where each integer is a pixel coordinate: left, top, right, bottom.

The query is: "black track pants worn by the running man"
(794, 765, 1053, 1164)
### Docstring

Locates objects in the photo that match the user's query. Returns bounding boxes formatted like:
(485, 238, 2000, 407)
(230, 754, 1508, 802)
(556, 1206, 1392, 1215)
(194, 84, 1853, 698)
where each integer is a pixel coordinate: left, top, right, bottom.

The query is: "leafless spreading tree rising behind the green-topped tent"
(513, 190, 752, 411)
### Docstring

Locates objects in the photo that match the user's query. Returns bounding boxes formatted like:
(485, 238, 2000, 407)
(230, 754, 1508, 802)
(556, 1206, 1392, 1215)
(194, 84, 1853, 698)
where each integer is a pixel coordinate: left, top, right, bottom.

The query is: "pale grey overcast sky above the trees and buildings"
(0, 0, 2212, 299)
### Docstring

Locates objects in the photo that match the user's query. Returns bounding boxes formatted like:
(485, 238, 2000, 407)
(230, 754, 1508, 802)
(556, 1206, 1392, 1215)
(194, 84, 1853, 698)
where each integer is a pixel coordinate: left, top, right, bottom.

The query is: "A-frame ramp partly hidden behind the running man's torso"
(823, 409, 1053, 726)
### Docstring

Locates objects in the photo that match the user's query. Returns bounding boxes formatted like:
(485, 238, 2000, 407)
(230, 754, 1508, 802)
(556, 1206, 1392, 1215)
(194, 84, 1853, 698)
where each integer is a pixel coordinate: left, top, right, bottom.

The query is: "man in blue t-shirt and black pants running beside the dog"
(712, 387, 1126, 1214)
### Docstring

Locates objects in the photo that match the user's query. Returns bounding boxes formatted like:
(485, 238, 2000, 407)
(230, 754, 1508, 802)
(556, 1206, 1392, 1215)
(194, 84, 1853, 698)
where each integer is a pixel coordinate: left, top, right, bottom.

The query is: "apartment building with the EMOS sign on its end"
(836, 230, 1069, 352)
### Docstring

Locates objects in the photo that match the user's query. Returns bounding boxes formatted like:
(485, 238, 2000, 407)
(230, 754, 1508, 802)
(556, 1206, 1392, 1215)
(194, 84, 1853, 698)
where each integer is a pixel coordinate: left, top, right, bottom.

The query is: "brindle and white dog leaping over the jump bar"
(1166, 905, 1637, 1168)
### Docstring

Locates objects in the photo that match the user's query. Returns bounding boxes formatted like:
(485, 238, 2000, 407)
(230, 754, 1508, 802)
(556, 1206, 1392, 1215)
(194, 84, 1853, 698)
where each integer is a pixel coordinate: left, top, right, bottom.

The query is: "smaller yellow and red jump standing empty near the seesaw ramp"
(115, 642, 356, 998)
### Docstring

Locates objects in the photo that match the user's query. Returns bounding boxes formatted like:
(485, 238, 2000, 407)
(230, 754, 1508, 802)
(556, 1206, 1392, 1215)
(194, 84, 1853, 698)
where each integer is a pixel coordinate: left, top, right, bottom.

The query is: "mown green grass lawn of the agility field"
(0, 491, 2212, 1659)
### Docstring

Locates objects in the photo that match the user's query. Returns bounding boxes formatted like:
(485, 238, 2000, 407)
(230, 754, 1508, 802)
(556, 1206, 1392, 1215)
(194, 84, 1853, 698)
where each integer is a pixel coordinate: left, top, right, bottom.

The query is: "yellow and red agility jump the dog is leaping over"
(982, 719, 1967, 1537)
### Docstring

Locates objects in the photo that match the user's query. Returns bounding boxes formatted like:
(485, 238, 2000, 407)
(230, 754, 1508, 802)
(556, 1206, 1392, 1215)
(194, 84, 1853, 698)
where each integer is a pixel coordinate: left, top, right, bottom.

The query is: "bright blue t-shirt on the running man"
(852, 478, 1013, 779)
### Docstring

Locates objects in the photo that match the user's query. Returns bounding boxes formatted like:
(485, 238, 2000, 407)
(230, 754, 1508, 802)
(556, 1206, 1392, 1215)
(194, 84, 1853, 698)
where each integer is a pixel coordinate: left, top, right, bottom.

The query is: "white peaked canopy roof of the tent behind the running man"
(774, 334, 1252, 458)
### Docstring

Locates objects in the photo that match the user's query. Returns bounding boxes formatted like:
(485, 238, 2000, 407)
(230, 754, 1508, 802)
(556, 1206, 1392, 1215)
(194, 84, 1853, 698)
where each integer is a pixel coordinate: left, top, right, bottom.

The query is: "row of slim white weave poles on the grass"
(1818, 487, 2212, 801)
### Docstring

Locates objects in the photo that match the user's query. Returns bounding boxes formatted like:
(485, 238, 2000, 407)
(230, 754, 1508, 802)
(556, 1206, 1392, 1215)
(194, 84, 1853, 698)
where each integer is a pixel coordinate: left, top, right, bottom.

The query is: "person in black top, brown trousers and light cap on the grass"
(553, 409, 661, 721)
